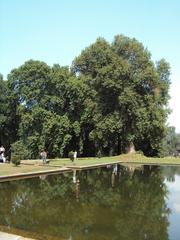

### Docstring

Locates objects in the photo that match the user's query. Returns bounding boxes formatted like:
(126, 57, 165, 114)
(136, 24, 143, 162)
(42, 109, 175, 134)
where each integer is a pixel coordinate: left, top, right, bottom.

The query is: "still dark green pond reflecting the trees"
(0, 165, 180, 240)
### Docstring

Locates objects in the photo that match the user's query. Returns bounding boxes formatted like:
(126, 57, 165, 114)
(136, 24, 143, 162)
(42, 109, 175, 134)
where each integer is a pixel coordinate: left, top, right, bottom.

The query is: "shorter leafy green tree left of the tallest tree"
(8, 60, 90, 158)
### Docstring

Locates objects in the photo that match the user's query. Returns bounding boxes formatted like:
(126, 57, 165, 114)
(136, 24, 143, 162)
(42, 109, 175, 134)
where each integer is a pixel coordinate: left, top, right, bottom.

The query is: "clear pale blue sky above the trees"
(0, 0, 180, 132)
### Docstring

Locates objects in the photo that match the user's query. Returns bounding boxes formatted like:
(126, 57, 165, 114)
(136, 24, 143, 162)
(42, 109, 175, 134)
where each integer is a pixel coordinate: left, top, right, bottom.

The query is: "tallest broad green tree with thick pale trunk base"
(72, 35, 169, 155)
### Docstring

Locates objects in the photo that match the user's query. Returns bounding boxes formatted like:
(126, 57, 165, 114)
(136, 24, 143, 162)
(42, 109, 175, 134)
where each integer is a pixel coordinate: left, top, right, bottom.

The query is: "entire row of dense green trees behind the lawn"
(0, 35, 170, 158)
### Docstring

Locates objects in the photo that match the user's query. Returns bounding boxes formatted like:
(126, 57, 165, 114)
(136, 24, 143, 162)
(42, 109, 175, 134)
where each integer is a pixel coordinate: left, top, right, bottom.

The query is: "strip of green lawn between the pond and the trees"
(0, 154, 180, 177)
